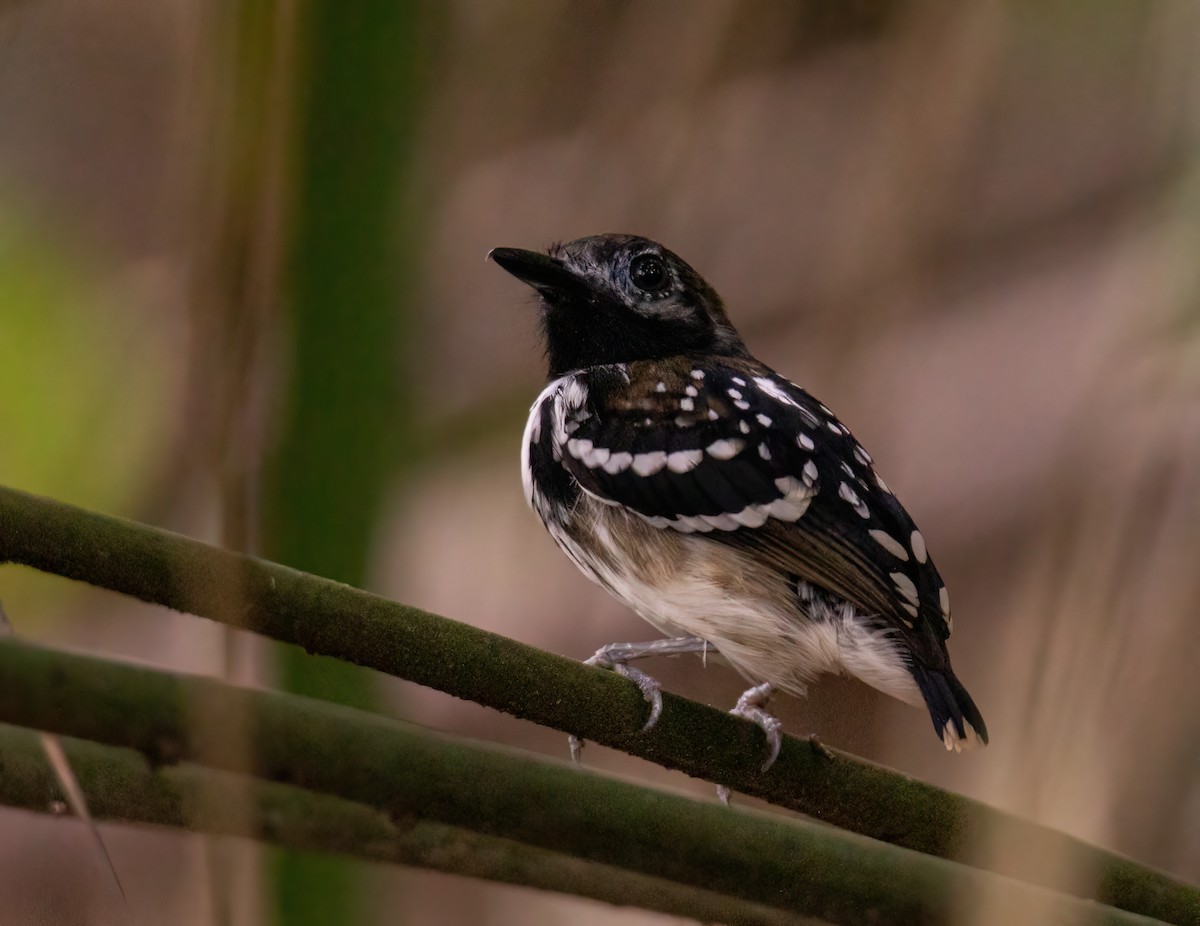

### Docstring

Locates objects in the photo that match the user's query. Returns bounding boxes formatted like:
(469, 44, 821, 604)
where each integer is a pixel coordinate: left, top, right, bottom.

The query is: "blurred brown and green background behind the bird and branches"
(0, 0, 1200, 926)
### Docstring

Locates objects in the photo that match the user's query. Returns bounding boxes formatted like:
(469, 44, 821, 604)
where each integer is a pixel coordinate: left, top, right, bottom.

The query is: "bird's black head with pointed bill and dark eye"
(491, 235, 745, 377)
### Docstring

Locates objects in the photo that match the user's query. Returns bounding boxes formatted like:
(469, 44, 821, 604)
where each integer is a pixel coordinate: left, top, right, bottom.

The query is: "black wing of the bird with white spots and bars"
(562, 359, 949, 639)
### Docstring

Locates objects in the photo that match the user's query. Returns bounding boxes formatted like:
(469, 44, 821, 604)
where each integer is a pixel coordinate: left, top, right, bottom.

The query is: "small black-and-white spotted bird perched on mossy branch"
(491, 235, 988, 765)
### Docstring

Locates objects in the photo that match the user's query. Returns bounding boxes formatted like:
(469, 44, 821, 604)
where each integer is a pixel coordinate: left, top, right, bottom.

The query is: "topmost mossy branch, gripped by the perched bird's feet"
(0, 488, 1200, 924)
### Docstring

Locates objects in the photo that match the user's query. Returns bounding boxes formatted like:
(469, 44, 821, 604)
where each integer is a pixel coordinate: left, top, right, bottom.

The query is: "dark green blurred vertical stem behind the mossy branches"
(263, 0, 434, 926)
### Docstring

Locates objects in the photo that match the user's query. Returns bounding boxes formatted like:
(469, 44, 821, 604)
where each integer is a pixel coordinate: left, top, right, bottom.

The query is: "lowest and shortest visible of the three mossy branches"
(0, 724, 815, 926)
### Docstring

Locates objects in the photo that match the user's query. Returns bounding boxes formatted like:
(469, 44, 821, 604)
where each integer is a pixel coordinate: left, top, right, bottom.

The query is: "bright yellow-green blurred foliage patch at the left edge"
(0, 201, 175, 630)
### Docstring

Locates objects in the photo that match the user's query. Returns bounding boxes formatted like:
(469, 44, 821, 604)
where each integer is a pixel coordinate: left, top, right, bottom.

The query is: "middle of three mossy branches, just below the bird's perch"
(0, 641, 1166, 926)
